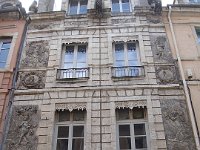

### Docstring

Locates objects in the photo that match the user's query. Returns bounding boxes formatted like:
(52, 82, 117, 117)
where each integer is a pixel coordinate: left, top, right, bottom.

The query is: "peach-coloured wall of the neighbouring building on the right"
(163, 5, 200, 148)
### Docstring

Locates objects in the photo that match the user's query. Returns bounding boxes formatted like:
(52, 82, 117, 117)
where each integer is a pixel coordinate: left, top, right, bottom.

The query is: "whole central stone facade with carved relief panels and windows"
(2, 0, 196, 150)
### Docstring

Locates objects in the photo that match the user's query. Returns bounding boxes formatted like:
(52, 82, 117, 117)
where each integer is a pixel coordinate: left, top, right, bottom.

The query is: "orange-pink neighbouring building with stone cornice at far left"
(0, 0, 26, 147)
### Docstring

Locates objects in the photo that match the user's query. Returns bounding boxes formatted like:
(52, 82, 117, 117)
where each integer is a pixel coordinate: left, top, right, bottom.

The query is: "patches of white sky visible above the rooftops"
(20, 0, 173, 12)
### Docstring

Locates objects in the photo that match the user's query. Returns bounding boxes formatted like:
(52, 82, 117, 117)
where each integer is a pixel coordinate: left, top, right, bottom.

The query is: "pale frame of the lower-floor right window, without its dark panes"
(116, 108, 150, 150)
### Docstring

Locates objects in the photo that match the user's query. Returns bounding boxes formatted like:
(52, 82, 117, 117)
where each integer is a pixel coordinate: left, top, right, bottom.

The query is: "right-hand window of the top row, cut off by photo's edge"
(112, 0, 131, 13)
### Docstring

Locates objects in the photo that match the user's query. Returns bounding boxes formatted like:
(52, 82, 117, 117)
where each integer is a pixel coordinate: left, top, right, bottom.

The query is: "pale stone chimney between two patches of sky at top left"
(38, 0, 55, 13)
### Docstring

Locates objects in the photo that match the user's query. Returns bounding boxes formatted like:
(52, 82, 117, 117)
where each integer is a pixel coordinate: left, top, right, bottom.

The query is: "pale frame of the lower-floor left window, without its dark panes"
(54, 110, 87, 150)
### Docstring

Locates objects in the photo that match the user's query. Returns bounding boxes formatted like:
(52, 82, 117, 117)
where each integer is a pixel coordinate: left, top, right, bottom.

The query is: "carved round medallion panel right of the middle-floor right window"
(156, 66, 177, 83)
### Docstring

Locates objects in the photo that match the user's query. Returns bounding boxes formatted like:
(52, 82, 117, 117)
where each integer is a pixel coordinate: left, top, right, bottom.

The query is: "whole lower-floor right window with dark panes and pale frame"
(116, 108, 148, 150)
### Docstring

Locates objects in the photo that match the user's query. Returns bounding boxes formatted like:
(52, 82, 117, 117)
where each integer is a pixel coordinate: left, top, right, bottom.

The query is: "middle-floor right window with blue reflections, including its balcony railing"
(112, 42, 143, 77)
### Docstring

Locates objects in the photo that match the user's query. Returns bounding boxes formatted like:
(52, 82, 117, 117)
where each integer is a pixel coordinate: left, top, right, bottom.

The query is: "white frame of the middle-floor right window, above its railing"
(113, 41, 141, 67)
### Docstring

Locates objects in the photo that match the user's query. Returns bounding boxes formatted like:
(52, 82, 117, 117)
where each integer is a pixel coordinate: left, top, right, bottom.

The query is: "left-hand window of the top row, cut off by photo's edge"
(69, 0, 87, 15)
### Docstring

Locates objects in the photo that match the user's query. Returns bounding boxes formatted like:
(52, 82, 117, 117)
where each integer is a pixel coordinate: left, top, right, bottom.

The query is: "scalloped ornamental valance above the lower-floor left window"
(56, 103, 87, 112)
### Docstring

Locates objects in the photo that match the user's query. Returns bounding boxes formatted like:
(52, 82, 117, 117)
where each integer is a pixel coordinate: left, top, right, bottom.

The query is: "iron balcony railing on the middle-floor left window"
(57, 68, 89, 80)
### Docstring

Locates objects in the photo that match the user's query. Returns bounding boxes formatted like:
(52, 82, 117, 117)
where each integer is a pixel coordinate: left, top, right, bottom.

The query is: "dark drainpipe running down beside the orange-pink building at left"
(0, 16, 31, 150)
